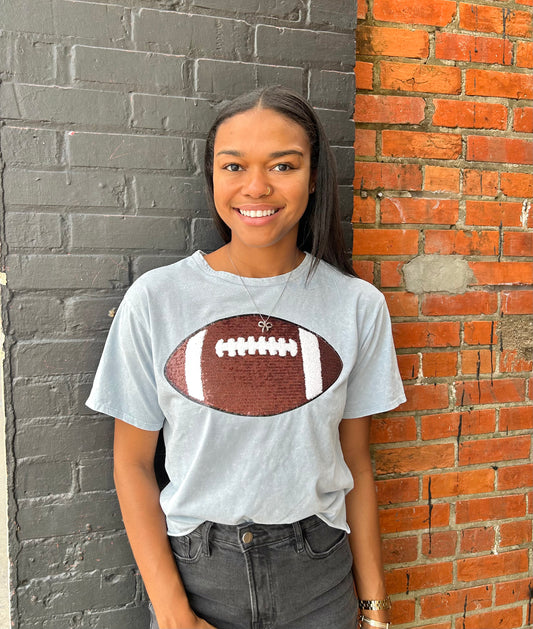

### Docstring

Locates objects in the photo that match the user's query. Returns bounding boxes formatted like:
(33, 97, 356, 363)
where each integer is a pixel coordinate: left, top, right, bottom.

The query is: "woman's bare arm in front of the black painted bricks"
(114, 419, 214, 629)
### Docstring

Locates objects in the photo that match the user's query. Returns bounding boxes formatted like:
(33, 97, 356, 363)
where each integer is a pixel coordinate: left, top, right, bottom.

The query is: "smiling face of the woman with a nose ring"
(213, 109, 314, 250)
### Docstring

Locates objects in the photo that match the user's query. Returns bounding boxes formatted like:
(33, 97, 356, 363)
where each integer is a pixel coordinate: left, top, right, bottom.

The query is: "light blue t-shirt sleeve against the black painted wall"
(86, 294, 165, 430)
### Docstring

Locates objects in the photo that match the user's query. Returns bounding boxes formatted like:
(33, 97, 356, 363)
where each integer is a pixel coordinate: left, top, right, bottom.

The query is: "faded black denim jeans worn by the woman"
(150, 516, 357, 629)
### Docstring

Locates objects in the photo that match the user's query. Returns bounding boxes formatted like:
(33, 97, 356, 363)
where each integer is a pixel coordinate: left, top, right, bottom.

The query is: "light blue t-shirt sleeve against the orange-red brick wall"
(343, 294, 405, 418)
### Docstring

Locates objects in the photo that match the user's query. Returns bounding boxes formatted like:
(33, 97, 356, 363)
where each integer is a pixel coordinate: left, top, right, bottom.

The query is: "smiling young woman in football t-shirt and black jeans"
(88, 87, 405, 629)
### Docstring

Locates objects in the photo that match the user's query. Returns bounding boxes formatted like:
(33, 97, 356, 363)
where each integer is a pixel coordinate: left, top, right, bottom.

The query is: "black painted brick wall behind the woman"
(0, 0, 356, 629)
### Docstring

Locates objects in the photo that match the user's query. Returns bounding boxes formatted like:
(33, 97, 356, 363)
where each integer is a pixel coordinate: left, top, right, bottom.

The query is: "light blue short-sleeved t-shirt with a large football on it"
(87, 251, 405, 535)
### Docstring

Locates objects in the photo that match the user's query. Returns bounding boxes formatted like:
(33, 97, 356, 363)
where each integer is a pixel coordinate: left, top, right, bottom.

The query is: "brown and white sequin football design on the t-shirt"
(165, 314, 342, 417)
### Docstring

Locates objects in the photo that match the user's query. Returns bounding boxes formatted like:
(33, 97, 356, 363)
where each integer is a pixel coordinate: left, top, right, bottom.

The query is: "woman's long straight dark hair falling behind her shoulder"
(204, 85, 356, 276)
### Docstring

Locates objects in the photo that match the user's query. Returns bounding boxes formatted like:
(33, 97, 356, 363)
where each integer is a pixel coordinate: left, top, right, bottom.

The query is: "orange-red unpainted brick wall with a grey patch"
(353, 0, 533, 629)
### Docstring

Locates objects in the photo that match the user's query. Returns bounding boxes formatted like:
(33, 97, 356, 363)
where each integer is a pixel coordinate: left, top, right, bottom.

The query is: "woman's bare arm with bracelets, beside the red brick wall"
(339, 417, 390, 622)
